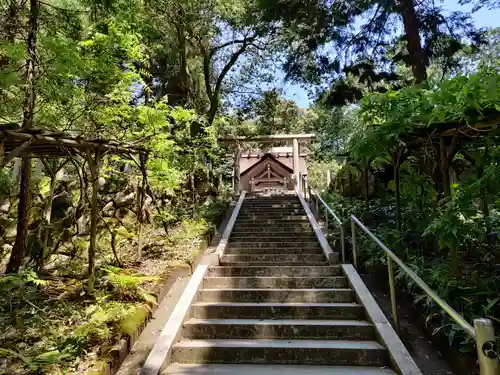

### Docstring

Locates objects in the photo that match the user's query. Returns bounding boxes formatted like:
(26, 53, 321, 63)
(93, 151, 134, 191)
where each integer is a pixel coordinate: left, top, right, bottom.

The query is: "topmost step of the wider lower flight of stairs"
(207, 265, 342, 277)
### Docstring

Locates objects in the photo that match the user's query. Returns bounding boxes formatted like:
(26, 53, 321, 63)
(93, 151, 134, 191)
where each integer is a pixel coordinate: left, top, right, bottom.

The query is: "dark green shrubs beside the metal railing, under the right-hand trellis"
(327, 195, 500, 352)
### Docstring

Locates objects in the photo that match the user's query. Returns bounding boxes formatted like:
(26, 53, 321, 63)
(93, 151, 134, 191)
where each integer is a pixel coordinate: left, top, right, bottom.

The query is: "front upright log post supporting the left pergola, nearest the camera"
(87, 149, 101, 292)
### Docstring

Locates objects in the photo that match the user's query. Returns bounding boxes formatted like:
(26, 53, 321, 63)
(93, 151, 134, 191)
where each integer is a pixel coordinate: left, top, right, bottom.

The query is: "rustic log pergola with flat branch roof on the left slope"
(0, 124, 149, 289)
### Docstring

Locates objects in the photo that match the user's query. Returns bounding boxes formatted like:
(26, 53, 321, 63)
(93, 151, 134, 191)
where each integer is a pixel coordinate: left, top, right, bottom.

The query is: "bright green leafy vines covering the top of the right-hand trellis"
(360, 67, 500, 132)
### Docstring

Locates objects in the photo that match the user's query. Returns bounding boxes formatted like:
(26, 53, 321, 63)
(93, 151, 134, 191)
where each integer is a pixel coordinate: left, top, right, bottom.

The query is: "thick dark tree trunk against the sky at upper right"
(400, 0, 427, 83)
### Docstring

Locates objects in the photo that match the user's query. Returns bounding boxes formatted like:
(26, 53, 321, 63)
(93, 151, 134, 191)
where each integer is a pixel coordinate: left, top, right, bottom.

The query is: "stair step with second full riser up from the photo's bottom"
(183, 319, 375, 340)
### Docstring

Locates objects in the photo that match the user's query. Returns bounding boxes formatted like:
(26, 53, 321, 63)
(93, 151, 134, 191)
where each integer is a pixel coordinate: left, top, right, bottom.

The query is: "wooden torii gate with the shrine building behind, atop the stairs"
(219, 134, 315, 192)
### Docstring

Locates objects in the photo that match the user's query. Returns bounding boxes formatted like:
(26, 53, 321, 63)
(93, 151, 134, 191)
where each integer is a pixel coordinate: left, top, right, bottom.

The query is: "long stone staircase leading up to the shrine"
(163, 195, 395, 375)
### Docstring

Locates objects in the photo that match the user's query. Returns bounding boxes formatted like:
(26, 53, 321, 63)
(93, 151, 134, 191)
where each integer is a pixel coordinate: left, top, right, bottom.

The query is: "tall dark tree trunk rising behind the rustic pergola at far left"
(6, 0, 39, 273)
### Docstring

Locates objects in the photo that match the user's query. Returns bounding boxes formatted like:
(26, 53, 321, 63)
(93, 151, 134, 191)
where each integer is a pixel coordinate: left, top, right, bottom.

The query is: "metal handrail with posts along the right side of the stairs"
(300, 176, 500, 375)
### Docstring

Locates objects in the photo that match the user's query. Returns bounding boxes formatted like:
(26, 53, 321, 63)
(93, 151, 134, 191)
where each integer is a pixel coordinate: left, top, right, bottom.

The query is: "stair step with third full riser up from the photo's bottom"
(191, 302, 365, 320)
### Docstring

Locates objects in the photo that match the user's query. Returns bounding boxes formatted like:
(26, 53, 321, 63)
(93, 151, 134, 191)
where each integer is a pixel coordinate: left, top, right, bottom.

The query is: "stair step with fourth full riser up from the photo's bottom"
(198, 288, 354, 303)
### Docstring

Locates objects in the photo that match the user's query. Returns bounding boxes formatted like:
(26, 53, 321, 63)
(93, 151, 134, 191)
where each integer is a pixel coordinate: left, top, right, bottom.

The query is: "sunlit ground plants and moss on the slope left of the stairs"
(0, 209, 225, 375)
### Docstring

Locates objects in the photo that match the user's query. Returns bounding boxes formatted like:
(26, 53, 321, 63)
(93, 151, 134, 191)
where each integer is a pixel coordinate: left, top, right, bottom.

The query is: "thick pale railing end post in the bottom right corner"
(474, 318, 499, 375)
